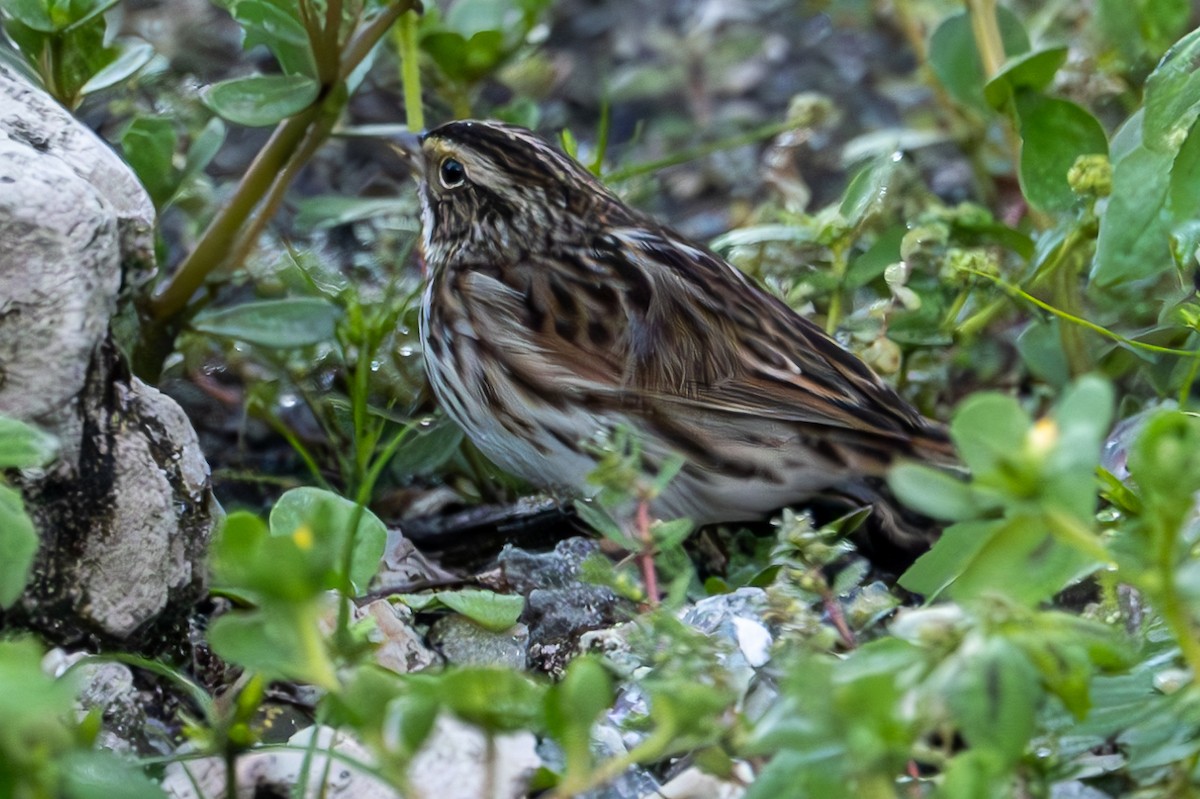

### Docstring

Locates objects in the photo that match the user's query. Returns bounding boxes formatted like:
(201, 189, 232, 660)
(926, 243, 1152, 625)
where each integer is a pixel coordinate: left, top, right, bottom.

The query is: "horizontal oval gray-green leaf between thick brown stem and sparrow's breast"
(192, 298, 342, 349)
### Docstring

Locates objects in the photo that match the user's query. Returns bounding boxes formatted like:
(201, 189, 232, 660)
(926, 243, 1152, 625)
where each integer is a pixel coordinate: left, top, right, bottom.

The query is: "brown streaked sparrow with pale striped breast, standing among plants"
(420, 121, 953, 547)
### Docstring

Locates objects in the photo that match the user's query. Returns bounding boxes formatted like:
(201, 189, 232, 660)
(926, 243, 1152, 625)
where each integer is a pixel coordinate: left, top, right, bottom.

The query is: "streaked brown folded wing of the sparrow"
(458, 218, 953, 470)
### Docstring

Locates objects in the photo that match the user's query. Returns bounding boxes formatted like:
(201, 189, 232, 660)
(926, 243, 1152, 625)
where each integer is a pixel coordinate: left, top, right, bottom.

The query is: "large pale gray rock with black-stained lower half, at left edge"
(0, 65, 220, 649)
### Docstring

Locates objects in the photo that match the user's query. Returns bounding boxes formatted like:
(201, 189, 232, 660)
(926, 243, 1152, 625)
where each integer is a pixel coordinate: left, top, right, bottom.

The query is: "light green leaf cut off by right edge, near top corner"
(1137, 29, 1200, 152)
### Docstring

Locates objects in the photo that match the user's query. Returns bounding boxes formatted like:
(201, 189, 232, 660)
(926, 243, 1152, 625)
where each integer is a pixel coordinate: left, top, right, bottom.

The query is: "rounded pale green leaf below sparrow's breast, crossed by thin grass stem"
(270, 486, 386, 587)
